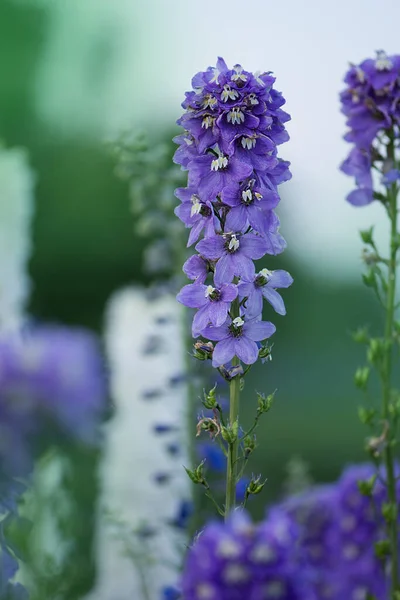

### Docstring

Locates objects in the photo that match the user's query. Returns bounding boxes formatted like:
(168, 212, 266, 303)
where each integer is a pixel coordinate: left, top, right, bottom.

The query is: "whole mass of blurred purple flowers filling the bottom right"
(182, 465, 396, 600)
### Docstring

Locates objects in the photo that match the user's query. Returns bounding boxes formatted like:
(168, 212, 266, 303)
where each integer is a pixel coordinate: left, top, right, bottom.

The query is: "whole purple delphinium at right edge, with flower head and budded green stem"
(341, 51, 400, 598)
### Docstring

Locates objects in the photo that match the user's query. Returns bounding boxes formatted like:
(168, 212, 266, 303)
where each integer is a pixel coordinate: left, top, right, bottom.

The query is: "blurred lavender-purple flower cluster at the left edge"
(0, 327, 107, 600)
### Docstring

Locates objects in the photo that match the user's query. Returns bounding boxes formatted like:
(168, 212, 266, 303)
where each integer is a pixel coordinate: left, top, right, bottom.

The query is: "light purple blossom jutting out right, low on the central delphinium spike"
(238, 269, 293, 319)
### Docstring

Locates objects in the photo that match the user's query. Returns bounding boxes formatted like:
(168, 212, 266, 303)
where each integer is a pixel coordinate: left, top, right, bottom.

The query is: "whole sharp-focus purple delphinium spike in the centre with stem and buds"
(174, 58, 292, 516)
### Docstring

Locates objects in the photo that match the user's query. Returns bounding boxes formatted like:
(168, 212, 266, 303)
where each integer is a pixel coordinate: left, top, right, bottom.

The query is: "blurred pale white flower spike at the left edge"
(0, 145, 35, 331)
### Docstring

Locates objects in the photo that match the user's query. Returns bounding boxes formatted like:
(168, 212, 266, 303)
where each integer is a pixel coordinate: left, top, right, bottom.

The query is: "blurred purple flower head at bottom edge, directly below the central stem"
(182, 511, 314, 600)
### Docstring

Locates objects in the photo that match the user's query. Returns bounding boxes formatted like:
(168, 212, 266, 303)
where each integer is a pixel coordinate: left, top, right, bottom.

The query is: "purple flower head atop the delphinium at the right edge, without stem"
(340, 50, 400, 206)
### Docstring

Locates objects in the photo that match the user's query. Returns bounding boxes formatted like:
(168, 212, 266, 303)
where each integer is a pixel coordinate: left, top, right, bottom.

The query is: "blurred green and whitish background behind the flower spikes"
(0, 0, 400, 511)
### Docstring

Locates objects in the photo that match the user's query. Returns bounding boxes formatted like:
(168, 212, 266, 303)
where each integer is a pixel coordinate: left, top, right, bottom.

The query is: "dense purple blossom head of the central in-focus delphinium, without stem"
(174, 58, 291, 366)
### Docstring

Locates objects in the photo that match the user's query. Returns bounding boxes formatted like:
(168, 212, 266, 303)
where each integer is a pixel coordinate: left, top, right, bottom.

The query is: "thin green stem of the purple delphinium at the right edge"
(382, 132, 399, 598)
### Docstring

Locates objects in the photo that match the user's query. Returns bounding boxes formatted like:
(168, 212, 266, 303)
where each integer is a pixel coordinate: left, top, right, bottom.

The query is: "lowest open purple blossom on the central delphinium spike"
(202, 317, 276, 367)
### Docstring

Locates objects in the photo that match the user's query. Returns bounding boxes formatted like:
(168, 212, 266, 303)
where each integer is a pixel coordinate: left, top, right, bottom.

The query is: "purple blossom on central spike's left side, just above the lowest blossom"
(177, 283, 238, 337)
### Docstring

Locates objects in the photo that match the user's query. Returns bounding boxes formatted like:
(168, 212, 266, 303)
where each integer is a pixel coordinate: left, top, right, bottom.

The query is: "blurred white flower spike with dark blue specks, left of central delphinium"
(93, 288, 191, 600)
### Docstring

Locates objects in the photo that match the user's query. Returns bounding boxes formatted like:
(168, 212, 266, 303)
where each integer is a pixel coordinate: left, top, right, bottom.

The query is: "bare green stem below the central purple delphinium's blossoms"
(225, 356, 240, 519)
